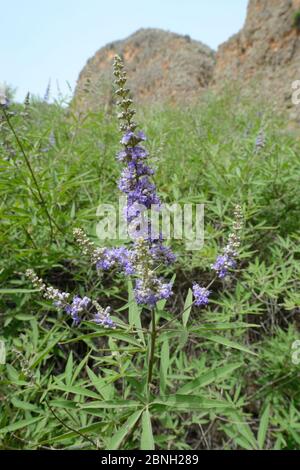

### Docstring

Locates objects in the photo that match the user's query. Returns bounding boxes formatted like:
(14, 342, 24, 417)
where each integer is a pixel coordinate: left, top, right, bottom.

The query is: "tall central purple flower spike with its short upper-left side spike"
(74, 56, 175, 306)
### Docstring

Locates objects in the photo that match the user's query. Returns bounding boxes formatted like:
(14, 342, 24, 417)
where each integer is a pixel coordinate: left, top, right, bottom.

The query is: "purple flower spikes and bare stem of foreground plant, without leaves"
(26, 56, 243, 412)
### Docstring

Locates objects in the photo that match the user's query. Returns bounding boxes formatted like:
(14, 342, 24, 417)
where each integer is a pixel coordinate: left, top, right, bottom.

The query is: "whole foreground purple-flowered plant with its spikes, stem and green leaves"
(26, 56, 253, 449)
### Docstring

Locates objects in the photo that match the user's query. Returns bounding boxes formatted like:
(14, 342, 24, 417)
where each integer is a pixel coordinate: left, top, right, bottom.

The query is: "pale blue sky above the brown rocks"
(0, 0, 248, 100)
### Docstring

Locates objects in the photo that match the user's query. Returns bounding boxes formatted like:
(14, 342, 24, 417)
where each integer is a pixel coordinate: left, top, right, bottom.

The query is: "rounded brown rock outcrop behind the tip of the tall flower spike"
(75, 29, 215, 110)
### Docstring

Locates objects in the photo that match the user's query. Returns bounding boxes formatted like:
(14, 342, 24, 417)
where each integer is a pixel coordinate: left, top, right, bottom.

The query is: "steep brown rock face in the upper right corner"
(213, 0, 300, 117)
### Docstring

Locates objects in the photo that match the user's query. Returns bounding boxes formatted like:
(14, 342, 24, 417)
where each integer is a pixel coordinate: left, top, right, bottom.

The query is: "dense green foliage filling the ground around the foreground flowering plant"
(0, 92, 300, 449)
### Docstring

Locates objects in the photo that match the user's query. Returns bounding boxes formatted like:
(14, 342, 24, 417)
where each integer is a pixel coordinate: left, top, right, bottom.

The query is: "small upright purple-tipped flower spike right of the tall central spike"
(211, 205, 243, 279)
